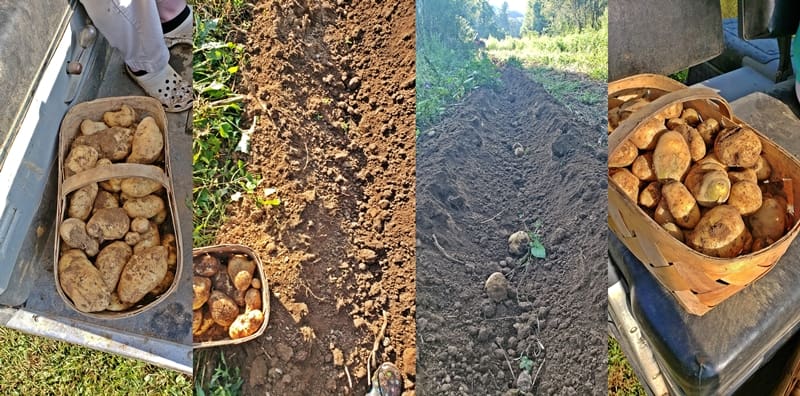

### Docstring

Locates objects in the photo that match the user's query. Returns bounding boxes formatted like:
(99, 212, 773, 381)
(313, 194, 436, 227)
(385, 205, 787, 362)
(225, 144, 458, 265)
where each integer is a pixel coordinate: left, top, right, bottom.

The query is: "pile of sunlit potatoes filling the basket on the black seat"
(608, 90, 793, 258)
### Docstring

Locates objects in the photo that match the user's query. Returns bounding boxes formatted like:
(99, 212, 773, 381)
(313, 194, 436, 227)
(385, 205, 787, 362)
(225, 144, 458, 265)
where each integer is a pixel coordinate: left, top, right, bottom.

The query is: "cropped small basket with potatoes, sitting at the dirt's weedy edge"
(192, 245, 269, 348)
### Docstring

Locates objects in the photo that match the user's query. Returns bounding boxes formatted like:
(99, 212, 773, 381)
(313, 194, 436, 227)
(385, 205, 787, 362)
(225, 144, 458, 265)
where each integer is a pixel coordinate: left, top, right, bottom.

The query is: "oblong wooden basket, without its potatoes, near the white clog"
(53, 96, 183, 319)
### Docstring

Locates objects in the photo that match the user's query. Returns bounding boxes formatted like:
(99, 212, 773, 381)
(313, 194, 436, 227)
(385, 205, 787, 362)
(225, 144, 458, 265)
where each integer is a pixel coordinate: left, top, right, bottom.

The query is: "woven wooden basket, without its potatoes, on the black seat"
(608, 79, 800, 315)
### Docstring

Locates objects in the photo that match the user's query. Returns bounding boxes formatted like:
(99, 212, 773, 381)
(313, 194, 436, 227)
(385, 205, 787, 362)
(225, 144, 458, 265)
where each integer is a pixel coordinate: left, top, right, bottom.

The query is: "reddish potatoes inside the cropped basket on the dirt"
(192, 254, 264, 342)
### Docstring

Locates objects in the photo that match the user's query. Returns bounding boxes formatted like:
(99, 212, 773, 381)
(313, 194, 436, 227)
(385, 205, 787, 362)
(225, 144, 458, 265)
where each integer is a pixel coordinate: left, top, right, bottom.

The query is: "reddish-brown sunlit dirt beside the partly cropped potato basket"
(206, 0, 416, 395)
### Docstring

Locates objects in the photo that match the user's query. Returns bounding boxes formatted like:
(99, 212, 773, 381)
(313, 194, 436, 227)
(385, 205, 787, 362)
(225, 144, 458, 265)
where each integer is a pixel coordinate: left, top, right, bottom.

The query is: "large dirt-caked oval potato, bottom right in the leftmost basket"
(117, 246, 167, 303)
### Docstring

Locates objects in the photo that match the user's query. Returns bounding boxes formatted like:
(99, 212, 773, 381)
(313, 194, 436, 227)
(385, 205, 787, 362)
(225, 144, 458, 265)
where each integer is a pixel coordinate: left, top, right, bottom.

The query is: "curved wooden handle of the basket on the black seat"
(608, 88, 733, 153)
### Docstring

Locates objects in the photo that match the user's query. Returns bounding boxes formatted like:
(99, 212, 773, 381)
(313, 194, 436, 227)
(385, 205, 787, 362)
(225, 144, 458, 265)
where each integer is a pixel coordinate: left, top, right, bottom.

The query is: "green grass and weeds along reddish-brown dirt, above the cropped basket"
(192, 0, 280, 247)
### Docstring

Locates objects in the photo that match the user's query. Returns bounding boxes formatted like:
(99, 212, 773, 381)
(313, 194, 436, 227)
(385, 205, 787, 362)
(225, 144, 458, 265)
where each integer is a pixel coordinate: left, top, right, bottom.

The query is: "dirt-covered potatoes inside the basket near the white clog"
(58, 105, 177, 312)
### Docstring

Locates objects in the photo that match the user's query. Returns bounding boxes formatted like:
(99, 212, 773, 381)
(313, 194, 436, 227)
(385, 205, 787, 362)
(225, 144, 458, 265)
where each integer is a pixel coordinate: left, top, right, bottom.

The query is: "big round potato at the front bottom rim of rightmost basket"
(686, 205, 750, 258)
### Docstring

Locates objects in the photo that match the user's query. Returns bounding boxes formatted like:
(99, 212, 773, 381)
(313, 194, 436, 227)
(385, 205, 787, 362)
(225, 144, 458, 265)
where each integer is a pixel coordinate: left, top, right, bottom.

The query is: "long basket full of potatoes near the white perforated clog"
(54, 96, 182, 319)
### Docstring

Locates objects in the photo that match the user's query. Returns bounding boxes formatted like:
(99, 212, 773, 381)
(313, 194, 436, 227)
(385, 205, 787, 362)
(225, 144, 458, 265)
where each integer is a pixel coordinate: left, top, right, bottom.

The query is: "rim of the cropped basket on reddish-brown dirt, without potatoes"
(192, 244, 269, 349)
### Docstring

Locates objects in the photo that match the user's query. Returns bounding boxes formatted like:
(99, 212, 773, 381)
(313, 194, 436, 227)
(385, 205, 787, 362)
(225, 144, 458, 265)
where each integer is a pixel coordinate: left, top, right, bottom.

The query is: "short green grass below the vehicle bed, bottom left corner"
(0, 327, 192, 395)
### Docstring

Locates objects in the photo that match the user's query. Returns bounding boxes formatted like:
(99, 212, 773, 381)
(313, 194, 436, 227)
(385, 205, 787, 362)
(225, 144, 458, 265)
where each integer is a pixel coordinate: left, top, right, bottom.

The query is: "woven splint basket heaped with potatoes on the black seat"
(608, 76, 800, 315)
